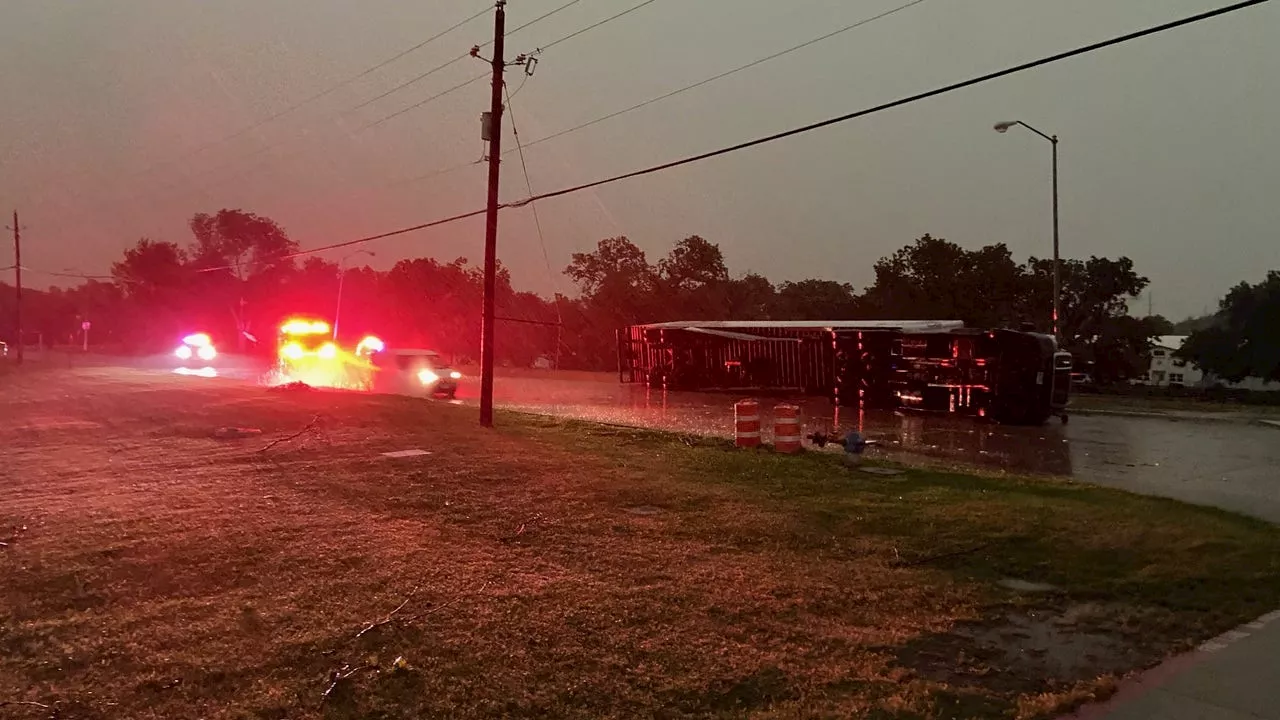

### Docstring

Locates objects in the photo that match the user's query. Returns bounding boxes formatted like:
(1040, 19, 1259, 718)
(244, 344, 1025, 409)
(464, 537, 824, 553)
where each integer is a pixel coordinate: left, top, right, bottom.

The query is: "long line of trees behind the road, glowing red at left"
(0, 203, 1280, 382)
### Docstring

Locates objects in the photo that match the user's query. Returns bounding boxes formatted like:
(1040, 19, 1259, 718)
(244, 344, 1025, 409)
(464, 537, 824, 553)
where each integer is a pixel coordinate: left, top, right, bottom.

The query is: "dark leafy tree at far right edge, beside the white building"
(1178, 270, 1280, 382)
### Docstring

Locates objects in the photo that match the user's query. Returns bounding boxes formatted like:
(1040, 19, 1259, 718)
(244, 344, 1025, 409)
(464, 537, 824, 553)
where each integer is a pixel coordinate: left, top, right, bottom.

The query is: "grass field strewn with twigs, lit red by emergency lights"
(0, 369, 1280, 720)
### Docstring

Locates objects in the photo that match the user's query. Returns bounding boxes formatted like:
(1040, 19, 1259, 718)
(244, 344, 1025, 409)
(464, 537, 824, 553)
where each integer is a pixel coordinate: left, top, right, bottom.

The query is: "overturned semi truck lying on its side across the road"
(618, 320, 1071, 424)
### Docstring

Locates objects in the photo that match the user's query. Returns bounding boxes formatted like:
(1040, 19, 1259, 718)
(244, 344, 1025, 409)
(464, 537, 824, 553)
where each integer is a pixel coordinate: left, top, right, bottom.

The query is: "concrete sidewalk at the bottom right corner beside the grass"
(1062, 611, 1280, 720)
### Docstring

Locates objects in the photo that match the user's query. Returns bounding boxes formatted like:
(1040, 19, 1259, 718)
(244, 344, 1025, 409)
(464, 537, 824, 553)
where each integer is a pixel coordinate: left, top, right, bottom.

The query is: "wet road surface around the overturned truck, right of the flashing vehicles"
(476, 377, 1280, 523)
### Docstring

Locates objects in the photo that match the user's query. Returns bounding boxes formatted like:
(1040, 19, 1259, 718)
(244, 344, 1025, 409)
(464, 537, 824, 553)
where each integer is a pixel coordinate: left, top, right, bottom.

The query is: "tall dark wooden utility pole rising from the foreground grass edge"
(471, 0, 507, 428)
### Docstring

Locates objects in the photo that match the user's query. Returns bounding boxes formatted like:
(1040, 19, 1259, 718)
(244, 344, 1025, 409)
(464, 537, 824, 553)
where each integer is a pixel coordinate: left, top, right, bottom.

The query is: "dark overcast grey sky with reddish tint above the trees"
(0, 0, 1280, 318)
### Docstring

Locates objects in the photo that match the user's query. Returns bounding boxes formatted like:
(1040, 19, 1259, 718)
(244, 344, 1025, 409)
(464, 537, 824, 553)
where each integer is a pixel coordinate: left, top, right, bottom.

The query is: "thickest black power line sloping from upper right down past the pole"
(77, 0, 1270, 272)
